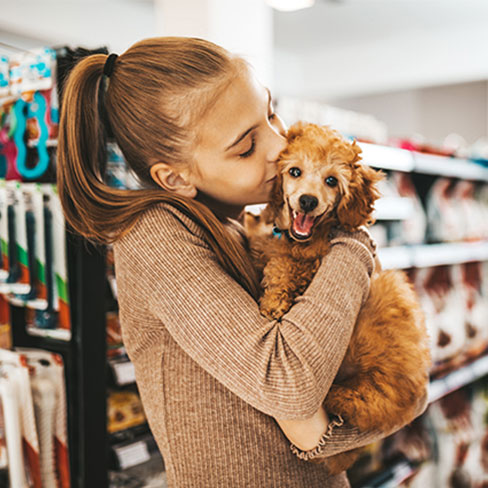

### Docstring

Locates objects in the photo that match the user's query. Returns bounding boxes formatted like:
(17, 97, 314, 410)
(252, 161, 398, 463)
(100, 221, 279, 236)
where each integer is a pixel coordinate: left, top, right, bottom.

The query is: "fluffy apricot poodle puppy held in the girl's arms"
(245, 123, 430, 474)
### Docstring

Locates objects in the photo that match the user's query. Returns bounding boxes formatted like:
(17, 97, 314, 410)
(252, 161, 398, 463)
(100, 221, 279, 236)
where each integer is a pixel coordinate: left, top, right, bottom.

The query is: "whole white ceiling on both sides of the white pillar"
(0, 0, 488, 99)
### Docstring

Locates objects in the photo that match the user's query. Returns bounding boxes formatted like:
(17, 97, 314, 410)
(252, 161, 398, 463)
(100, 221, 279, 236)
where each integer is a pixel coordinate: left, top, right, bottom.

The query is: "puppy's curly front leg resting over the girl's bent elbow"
(259, 256, 320, 320)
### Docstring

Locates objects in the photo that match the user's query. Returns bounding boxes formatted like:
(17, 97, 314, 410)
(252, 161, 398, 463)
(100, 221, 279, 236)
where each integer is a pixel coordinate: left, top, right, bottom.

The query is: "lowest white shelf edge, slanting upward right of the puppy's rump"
(429, 356, 488, 403)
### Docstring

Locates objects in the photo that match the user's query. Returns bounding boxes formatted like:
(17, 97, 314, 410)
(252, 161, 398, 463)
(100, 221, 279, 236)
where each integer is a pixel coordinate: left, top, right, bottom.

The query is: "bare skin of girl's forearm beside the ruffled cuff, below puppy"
(275, 406, 329, 451)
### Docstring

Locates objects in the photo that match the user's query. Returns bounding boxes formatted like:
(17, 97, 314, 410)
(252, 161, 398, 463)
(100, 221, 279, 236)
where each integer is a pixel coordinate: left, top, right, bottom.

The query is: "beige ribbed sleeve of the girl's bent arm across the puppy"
(117, 206, 374, 419)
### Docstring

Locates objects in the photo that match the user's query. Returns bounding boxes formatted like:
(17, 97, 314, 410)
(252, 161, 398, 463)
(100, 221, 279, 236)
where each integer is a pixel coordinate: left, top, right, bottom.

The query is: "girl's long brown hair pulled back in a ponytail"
(57, 37, 259, 298)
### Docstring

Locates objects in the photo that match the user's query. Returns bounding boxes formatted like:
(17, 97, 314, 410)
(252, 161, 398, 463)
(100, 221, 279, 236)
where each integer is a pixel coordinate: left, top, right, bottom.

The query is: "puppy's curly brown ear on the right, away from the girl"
(336, 161, 385, 231)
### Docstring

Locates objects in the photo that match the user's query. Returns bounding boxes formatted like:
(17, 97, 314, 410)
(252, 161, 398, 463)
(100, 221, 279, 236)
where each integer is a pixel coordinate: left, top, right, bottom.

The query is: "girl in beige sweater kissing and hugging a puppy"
(58, 38, 425, 488)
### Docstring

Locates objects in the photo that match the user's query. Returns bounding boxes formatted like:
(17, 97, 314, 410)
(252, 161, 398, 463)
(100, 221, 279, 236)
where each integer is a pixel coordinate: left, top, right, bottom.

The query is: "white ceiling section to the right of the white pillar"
(274, 0, 488, 101)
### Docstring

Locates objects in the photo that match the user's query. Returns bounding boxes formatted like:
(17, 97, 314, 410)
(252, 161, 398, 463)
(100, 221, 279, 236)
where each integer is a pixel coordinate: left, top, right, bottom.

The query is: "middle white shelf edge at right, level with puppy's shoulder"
(378, 241, 488, 269)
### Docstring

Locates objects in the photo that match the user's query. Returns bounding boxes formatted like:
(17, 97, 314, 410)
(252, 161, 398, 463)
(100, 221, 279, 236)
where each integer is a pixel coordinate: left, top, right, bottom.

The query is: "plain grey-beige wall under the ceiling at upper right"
(330, 81, 488, 144)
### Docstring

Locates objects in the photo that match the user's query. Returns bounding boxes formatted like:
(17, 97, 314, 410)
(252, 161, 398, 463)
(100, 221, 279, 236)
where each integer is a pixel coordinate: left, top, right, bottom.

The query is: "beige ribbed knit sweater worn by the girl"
(114, 200, 386, 488)
